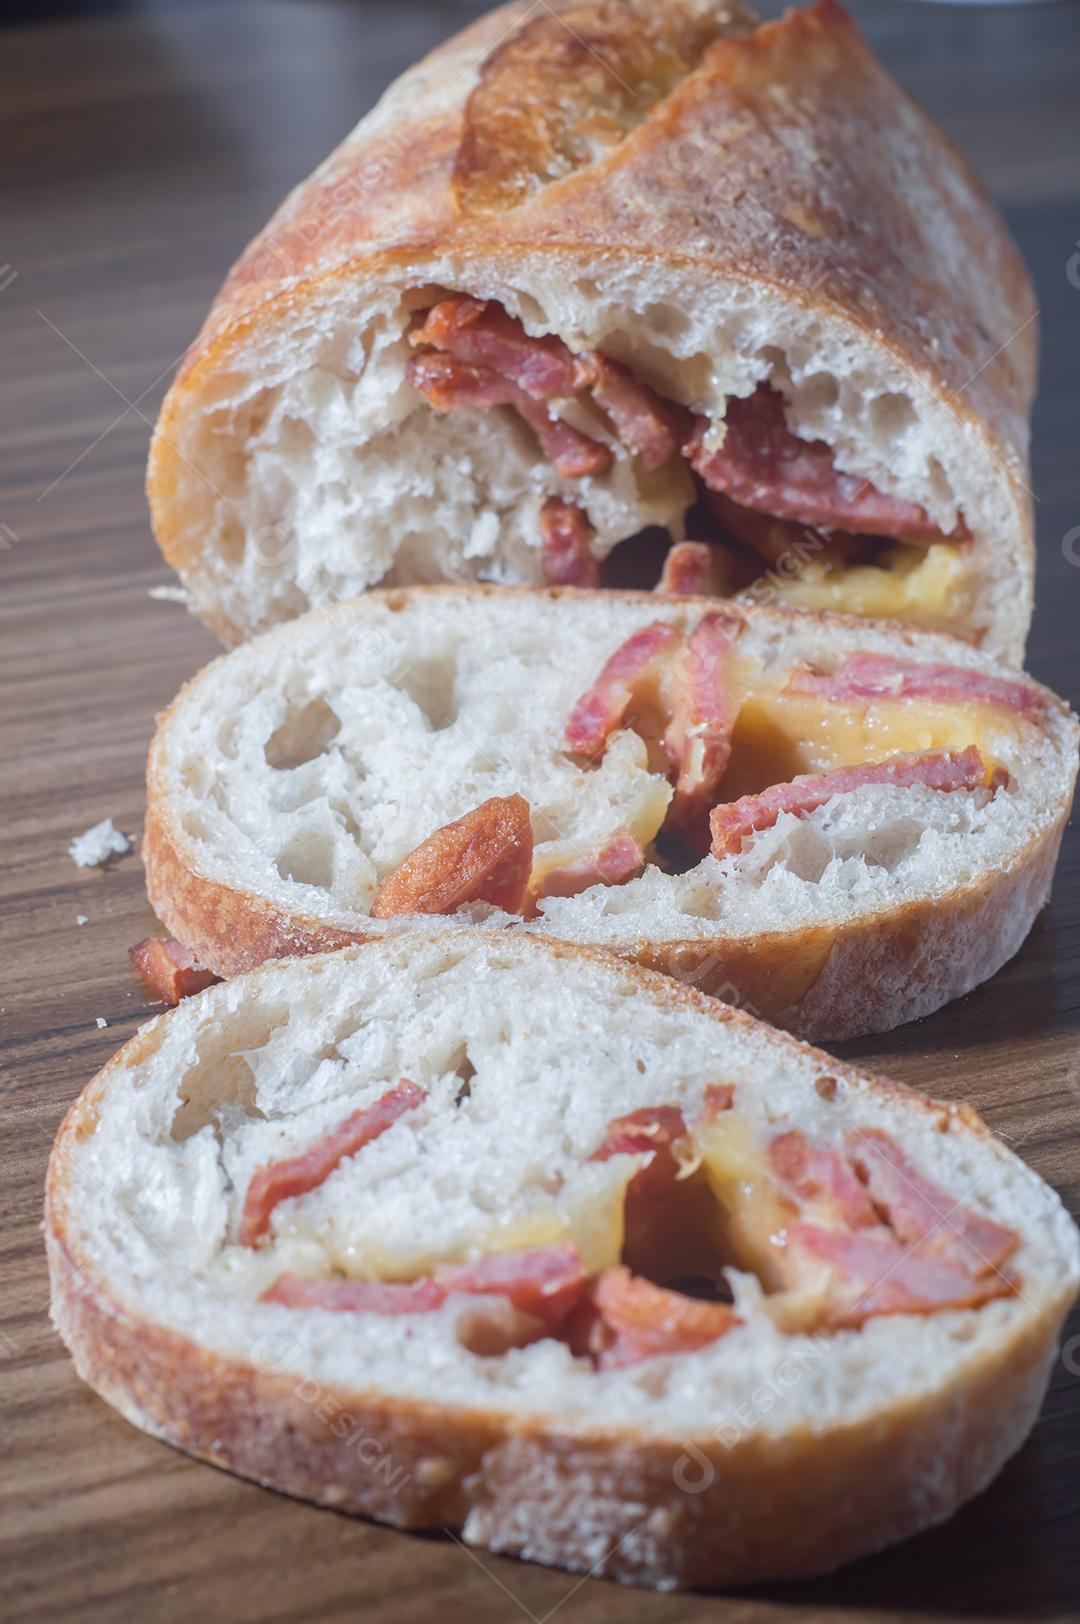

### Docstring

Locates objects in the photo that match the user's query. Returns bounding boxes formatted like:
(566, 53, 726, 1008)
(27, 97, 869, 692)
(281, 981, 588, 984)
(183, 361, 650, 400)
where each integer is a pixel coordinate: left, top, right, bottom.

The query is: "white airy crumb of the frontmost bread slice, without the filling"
(47, 932, 1080, 1437)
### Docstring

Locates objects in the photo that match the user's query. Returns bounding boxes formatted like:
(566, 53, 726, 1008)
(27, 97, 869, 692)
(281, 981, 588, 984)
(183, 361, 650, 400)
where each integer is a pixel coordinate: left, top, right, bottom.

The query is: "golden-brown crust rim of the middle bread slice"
(143, 585, 1070, 1043)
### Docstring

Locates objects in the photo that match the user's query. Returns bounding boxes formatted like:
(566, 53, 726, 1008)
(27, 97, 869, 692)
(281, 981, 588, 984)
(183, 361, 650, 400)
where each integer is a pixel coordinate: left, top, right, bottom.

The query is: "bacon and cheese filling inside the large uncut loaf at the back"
(406, 296, 971, 633)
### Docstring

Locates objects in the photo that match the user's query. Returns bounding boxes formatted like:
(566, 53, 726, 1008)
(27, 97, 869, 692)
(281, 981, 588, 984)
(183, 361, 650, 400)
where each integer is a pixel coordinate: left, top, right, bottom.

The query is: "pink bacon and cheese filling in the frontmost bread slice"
(250, 1078, 1020, 1371)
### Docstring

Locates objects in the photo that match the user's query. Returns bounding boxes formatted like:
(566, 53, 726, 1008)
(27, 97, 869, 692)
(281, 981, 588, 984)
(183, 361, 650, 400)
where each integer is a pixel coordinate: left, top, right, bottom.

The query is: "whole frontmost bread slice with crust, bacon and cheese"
(45, 931, 1080, 1585)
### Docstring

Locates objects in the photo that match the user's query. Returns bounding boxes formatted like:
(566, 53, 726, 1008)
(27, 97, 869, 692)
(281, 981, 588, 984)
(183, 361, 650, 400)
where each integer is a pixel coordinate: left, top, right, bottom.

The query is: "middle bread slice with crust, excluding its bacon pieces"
(143, 586, 1077, 1038)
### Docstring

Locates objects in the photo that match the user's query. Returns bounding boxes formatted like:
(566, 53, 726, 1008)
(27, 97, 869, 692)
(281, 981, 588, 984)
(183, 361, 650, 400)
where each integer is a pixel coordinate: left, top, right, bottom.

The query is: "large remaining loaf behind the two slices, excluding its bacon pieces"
(149, 0, 1036, 663)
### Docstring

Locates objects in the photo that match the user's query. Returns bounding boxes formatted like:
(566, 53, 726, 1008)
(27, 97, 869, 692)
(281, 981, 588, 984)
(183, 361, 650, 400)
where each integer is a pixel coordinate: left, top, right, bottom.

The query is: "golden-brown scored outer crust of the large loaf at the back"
(148, 0, 1036, 654)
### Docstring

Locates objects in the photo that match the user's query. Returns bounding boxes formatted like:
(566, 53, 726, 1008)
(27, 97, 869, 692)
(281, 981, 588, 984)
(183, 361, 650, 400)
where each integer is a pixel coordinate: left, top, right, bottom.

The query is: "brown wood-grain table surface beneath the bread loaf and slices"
(0, 0, 1080, 1624)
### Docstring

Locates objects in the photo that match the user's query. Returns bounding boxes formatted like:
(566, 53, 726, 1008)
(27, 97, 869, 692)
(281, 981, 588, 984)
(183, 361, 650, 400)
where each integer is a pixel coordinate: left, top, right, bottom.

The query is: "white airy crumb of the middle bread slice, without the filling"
(149, 588, 1077, 947)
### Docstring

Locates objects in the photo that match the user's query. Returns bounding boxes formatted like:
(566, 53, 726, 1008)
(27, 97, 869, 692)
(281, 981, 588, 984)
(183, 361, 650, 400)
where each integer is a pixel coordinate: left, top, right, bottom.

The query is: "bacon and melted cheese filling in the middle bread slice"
(370, 626, 1043, 919)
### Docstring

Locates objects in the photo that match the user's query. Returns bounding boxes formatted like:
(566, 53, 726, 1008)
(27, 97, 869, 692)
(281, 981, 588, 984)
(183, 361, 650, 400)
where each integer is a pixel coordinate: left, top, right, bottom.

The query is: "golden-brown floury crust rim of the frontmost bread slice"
(45, 937, 1074, 1587)
